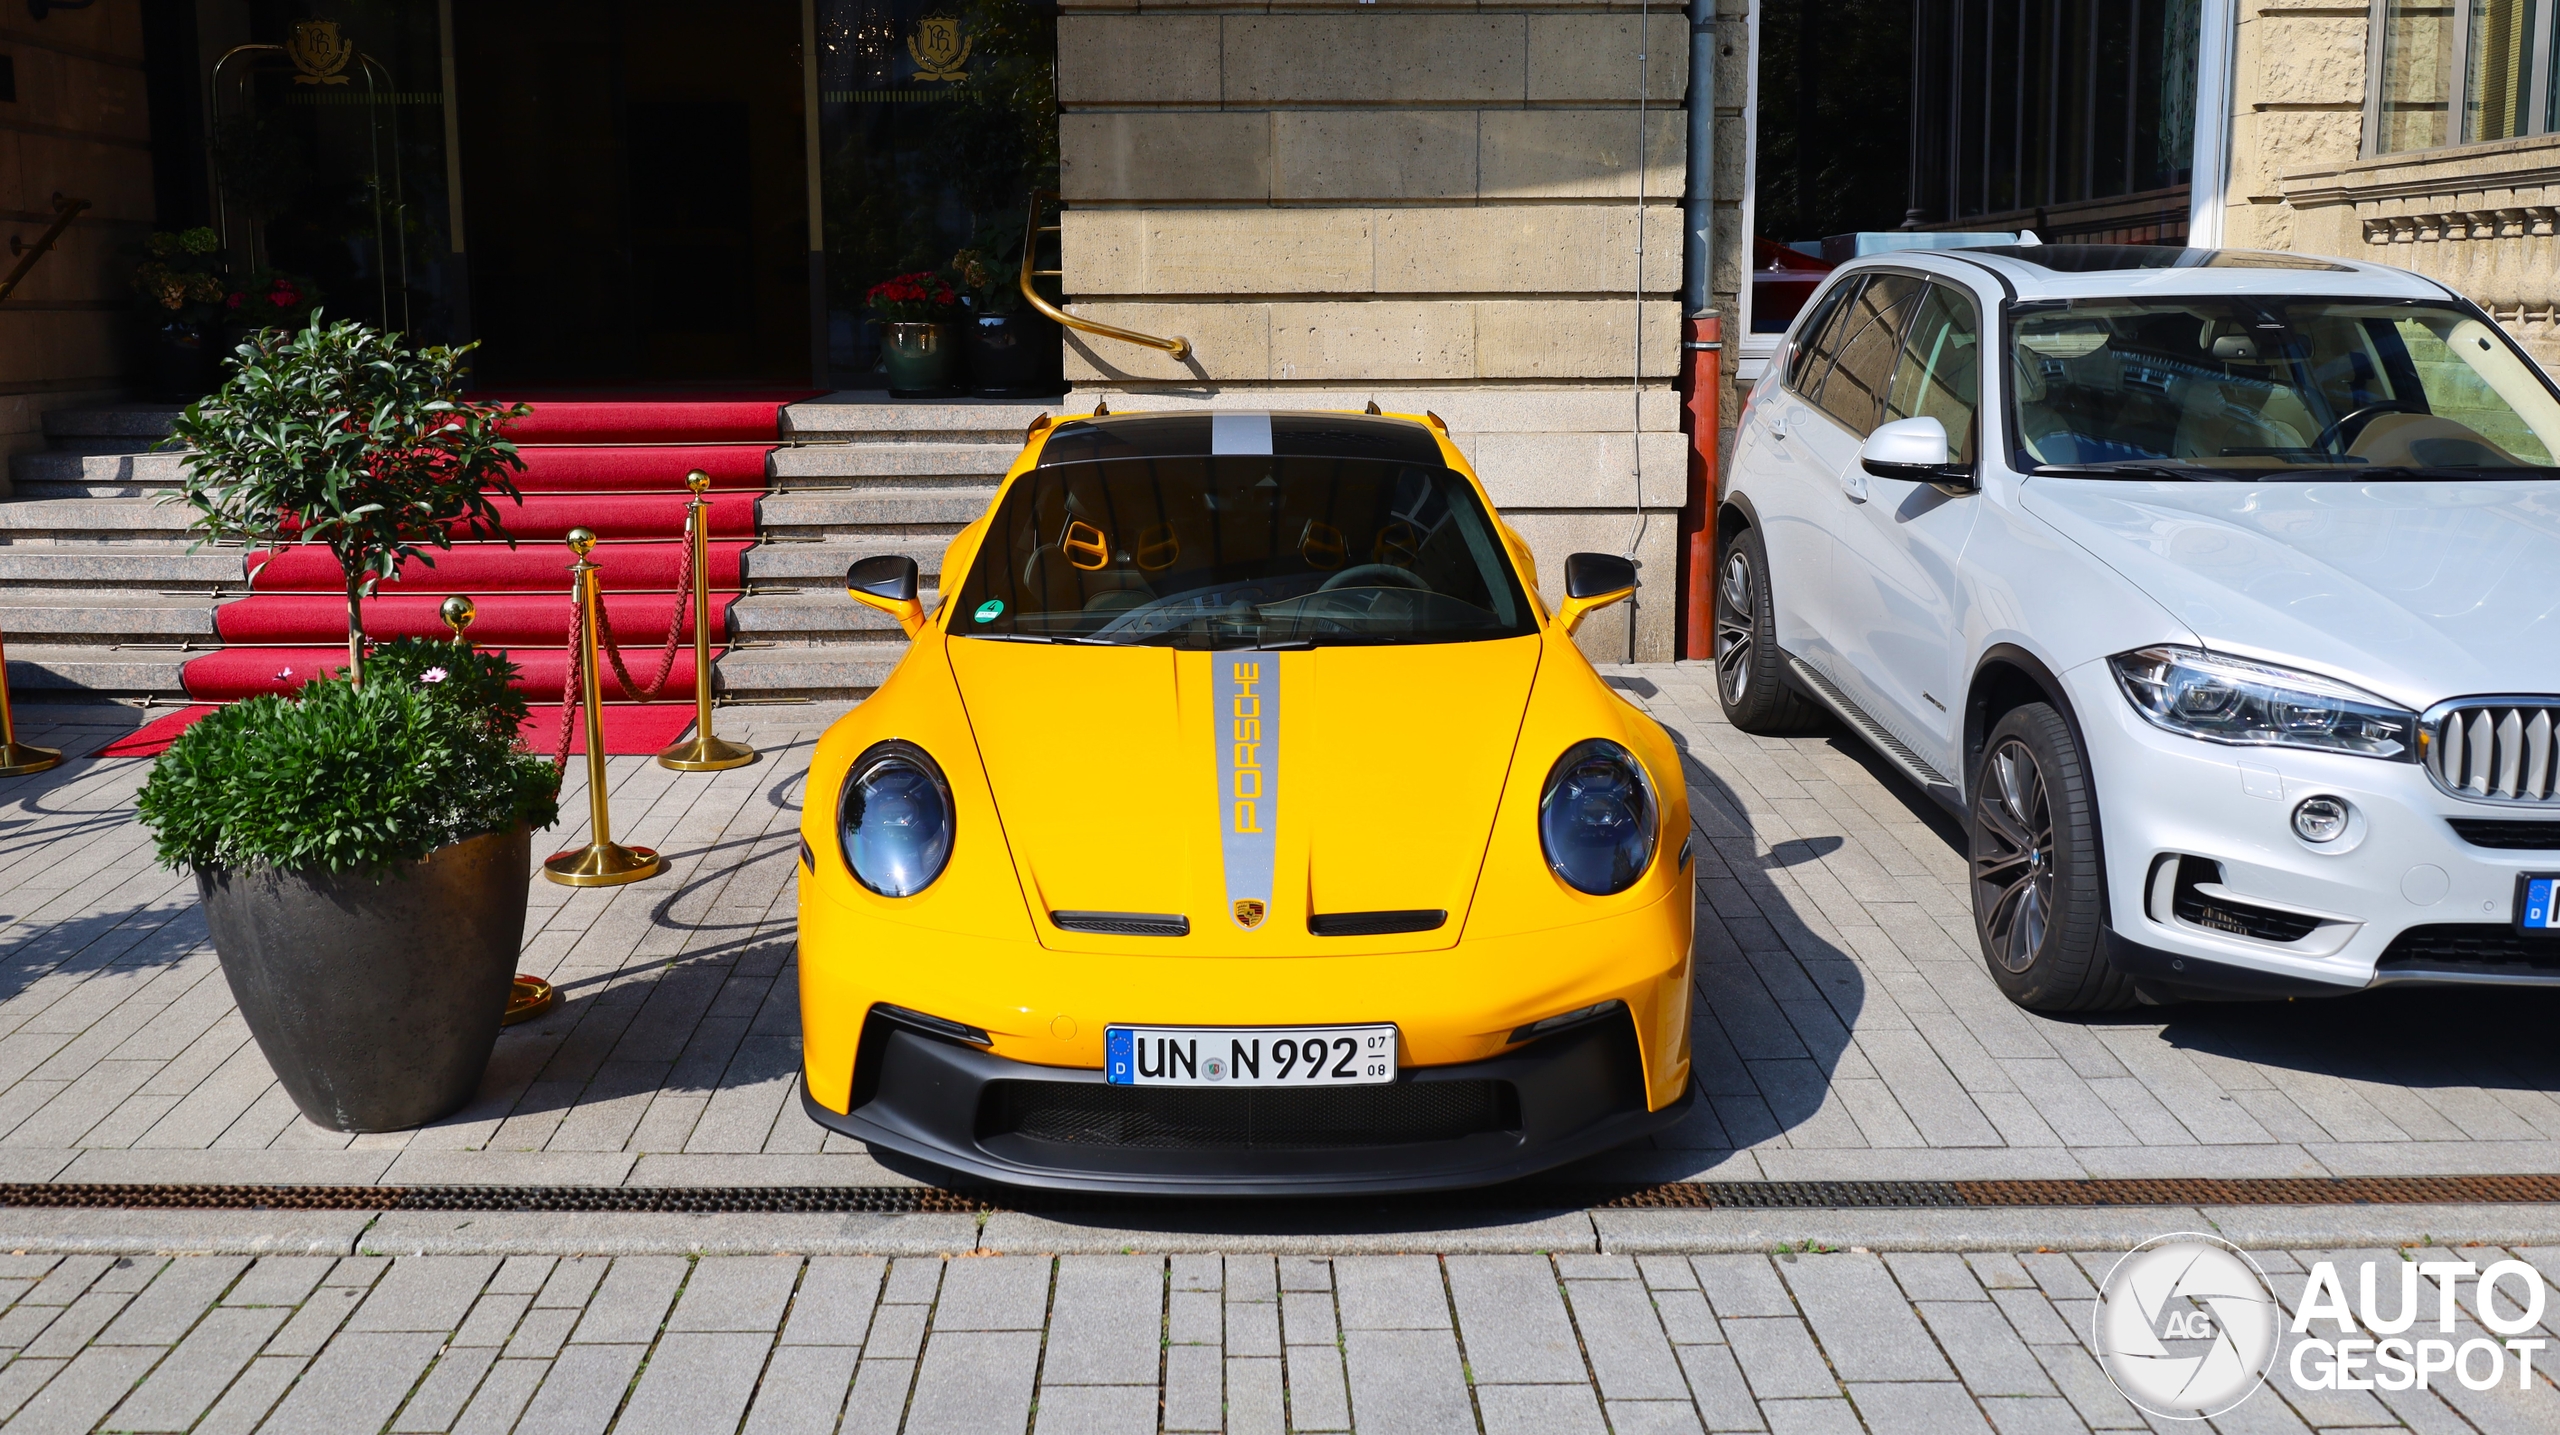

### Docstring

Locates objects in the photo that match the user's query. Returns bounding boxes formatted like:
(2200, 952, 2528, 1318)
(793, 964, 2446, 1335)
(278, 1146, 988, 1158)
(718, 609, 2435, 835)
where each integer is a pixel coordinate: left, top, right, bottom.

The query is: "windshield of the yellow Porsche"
(950, 455, 1536, 647)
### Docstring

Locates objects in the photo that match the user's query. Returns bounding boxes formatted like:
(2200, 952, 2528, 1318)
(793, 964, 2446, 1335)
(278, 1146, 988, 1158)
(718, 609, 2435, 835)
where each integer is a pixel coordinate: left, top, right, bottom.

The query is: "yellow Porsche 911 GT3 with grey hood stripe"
(799, 412, 1692, 1195)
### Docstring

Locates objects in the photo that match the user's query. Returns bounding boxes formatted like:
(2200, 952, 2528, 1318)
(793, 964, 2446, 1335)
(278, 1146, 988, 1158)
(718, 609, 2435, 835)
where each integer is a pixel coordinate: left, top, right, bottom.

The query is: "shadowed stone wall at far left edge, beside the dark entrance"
(0, 3, 151, 486)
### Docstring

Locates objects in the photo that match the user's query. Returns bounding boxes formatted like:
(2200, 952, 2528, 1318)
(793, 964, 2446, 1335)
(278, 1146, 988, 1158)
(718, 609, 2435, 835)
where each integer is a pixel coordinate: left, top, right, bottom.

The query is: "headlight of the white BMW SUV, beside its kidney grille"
(2107, 647, 2417, 762)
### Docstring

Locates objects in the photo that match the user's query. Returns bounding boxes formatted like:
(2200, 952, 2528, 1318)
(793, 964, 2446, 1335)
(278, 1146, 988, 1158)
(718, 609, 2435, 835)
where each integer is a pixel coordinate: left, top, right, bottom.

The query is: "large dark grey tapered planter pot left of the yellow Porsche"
(195, 829, 532, 1131)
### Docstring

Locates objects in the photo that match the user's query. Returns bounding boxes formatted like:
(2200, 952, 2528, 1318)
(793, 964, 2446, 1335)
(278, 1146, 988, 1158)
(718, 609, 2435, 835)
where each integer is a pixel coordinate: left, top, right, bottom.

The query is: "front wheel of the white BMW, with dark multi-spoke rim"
(1966, 703, 2135, 1010)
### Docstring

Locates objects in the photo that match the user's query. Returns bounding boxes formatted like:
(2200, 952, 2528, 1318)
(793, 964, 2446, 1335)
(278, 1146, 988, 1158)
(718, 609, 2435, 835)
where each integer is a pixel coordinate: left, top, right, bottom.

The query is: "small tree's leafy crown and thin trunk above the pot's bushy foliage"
(169, 312, 532, 683)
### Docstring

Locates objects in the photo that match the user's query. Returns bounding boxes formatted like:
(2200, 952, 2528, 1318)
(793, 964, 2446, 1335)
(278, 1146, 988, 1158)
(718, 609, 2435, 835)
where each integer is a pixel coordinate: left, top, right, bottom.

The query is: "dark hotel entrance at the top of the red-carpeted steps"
(180, 0, 1057, 389)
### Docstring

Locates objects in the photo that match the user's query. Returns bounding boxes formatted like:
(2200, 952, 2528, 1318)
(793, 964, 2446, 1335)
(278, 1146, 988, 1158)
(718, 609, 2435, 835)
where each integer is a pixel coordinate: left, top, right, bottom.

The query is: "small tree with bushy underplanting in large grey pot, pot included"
(138, 315, 558, 1131)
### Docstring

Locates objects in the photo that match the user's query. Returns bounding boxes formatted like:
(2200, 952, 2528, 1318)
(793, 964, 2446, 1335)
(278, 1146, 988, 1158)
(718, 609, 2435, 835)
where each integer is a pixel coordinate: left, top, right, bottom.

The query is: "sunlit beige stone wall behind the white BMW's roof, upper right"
(2222, 0, 2560, 368)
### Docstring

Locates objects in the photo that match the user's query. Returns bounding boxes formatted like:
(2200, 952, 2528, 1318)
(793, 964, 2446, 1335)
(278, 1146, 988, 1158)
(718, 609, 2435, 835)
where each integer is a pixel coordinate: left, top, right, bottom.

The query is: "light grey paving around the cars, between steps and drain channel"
(0, 665, 2560, 1184)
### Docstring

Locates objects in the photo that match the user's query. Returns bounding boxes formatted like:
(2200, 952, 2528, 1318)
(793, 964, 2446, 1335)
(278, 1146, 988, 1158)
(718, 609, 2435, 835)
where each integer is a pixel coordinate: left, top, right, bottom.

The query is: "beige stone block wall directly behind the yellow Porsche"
(1057, 0, 1748, 660)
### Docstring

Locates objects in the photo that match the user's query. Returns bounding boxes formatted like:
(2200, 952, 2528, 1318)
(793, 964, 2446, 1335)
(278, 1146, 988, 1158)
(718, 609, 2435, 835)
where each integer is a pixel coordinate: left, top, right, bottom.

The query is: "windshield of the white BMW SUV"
(2010, 297, 2560, 481)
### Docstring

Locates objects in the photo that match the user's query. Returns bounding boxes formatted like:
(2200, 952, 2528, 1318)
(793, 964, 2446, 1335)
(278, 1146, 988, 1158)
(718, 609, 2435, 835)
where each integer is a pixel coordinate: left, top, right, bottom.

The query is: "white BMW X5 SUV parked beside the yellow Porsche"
(1715, 246, 2560, 1010)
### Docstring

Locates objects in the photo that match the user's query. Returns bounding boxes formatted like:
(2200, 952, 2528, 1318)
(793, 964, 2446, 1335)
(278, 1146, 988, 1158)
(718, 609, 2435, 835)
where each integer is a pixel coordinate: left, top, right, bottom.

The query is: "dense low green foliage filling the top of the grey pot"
(136, 670, 561, 872)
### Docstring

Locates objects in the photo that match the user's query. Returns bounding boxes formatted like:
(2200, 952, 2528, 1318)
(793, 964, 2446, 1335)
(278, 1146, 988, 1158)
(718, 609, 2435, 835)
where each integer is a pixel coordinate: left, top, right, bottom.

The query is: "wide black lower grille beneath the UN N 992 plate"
(978, 1082, 1521, 1151)
